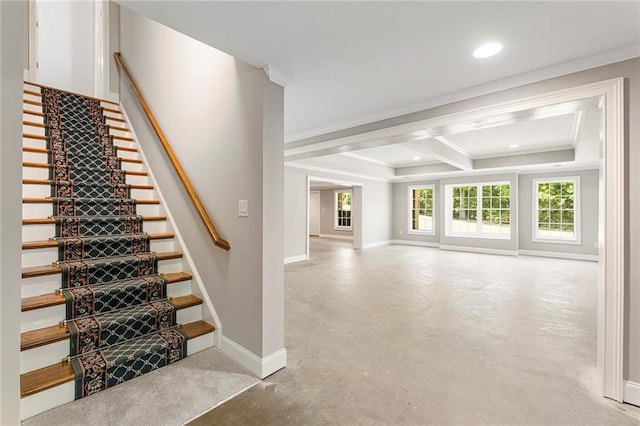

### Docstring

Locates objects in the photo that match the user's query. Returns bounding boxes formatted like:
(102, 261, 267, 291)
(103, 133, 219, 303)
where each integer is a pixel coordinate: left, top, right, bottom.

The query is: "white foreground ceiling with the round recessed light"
(120, 0, 640, 140)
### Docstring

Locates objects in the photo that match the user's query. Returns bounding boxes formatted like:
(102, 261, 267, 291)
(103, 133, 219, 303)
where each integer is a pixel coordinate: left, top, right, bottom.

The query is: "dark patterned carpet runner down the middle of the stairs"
(42, 88, 187, 399)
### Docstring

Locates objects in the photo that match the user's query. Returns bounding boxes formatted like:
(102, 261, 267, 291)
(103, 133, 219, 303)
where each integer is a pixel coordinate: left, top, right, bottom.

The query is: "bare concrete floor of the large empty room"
(191, 239, 640, 425)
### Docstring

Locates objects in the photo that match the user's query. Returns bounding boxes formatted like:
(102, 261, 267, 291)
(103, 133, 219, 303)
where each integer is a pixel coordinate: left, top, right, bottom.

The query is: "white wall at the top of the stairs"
(36, 0, 95, 95)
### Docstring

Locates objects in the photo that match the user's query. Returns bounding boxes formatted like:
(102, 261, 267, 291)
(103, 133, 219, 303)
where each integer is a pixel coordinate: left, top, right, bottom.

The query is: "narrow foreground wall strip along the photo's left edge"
(0, 1, 24, 425)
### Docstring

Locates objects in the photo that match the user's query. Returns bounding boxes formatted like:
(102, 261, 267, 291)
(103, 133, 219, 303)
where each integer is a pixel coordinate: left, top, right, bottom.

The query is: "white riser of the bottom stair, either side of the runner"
(20, 333, 215, 420)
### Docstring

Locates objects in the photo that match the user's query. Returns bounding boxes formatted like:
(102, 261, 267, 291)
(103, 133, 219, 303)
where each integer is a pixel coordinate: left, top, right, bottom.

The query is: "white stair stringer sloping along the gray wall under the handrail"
(120, 103, 222, 349)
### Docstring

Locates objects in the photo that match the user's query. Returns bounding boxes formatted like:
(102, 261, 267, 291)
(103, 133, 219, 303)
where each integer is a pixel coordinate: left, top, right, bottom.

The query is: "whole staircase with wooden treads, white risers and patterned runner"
(20, 83, 214, 419)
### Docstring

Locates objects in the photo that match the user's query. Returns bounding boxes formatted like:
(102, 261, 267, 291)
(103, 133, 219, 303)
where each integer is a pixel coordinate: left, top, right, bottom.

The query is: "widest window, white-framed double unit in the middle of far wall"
(445, 182, 511, 238)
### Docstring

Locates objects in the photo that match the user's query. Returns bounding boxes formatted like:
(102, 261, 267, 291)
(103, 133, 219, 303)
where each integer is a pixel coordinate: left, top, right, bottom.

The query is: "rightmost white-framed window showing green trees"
(533, 177, 580, 244)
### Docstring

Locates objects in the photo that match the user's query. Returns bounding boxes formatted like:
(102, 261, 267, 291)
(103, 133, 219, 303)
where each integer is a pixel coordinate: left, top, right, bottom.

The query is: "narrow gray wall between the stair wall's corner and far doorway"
(284, 169, 307, 259)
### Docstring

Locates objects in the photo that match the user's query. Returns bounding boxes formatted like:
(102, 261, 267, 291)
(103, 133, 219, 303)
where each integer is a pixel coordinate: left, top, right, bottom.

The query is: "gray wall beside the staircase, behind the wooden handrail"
(120, 7, 284, 357)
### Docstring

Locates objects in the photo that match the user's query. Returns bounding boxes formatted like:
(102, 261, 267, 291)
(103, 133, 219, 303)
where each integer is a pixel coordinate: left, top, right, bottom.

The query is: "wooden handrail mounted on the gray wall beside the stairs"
(113, 52, 231, 250)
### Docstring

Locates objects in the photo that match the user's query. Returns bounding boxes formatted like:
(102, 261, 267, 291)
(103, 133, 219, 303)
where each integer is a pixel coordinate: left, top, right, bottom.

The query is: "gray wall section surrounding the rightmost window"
(518, 170, 600, 255)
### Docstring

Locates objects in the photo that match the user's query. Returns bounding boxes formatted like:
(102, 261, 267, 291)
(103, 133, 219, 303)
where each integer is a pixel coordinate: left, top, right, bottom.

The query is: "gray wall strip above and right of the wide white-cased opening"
(298, 58, 640, 382)
